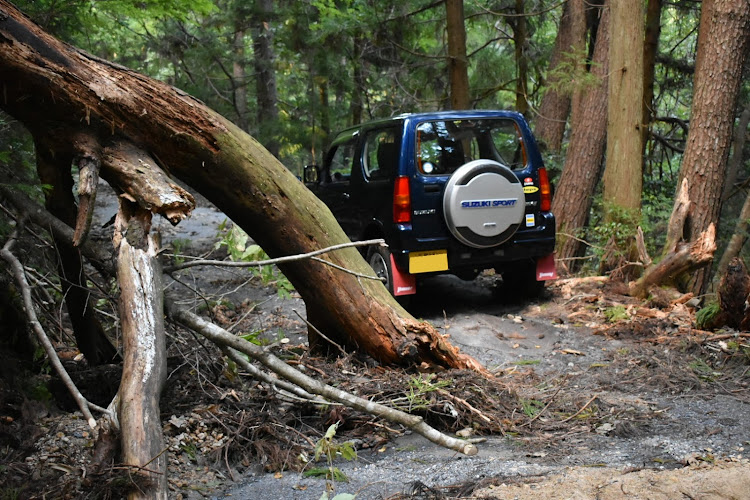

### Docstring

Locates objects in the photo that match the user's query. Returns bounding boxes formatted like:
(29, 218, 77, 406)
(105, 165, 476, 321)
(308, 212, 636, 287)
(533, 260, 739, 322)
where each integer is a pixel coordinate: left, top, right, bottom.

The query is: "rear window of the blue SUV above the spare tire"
(416, 118, 526, 175)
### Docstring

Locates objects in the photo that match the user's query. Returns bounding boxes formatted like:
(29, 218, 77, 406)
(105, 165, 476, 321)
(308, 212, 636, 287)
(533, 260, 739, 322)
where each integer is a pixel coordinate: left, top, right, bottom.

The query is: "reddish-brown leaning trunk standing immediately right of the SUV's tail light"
(552, 4, 609, 271)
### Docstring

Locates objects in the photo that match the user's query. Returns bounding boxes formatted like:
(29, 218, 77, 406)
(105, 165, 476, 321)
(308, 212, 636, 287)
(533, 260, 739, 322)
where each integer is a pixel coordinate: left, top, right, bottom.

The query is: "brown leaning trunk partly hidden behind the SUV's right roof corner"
(534, 0, 586, 152)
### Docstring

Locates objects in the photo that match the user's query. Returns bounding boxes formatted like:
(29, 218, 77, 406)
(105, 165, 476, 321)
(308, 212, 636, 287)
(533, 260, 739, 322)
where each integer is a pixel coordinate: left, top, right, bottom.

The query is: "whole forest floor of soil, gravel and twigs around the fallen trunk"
(0, 185, 750, 499)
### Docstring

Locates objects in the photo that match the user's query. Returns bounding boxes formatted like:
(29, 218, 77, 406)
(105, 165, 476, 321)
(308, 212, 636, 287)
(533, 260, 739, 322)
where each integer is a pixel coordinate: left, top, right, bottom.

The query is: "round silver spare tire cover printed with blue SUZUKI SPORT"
(443, 160, 526, 248)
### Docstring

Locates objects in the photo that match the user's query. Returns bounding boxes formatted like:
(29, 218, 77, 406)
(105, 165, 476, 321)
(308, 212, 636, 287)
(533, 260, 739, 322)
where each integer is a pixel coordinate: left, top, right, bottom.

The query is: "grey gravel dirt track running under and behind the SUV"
(86, 185, 750, 499)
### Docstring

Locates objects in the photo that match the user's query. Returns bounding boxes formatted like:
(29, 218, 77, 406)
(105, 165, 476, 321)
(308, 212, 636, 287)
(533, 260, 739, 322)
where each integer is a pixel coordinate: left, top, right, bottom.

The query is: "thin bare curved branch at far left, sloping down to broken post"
(0, 229, 101, 429)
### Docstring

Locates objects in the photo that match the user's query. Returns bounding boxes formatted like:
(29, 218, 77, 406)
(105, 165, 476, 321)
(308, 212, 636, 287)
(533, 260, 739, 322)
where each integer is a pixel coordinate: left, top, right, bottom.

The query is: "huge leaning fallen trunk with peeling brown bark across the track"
(0, 0, 480, 369)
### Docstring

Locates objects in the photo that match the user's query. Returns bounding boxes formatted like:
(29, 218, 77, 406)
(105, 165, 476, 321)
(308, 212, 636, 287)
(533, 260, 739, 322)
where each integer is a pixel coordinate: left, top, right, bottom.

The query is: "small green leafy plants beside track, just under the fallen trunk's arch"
(214, 220, 294, 298)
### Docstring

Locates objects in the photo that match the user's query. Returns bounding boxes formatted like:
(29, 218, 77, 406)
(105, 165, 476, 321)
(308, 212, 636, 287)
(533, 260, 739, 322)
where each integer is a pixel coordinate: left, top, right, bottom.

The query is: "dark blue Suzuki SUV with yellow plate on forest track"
(304, 110, 557, 297)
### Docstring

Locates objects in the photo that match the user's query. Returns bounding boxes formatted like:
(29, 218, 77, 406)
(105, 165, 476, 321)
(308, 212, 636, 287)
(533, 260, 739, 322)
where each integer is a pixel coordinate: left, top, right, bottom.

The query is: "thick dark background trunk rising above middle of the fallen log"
(253, 0, 279, 157)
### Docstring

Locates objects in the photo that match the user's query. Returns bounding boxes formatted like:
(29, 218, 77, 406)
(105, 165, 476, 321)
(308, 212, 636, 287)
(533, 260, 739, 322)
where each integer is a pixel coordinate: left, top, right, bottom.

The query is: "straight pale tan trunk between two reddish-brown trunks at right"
(602, 0, 644, 277)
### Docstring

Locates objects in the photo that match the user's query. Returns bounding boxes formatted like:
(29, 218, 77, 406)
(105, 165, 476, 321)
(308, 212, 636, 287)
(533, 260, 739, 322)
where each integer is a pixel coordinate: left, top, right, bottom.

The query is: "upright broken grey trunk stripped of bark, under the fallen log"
(116, 200, 168, 500)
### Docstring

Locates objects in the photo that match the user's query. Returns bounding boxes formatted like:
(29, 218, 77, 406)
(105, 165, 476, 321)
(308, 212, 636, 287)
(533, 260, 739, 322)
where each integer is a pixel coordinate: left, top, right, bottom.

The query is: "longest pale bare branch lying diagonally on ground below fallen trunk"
(166, 301, 478, 455)
